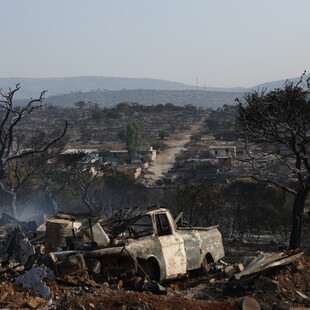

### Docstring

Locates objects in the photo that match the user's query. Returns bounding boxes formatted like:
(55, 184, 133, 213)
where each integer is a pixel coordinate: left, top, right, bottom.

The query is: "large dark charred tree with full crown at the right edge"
(236, 81, 310, 249)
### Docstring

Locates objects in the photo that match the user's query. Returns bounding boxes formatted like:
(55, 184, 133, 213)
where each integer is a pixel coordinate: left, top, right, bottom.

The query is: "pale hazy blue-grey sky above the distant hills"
(0, 0, 310, 87)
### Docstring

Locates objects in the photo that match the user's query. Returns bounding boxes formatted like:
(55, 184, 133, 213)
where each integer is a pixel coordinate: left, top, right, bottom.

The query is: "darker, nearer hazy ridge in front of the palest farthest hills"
(45, 89, 243, 108)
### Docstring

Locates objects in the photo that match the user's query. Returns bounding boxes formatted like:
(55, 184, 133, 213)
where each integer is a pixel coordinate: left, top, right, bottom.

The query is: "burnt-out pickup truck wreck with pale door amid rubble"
(42, 207, 224, 281)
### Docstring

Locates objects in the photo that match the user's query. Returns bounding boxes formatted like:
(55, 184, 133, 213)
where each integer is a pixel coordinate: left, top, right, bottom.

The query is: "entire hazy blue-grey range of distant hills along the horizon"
(0, 75, 309, 108)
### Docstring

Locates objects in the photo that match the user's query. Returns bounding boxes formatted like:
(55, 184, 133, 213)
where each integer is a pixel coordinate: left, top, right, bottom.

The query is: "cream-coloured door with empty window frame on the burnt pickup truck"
(155, 213, 186, 279)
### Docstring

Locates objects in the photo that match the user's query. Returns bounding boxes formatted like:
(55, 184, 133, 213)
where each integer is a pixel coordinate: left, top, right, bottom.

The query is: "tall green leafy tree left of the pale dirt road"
(118, 121, 145, 161)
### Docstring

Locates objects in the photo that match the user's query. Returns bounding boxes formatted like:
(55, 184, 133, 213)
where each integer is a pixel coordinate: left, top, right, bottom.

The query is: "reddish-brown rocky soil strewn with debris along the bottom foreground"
(0, 249, 310, 310)
